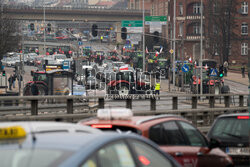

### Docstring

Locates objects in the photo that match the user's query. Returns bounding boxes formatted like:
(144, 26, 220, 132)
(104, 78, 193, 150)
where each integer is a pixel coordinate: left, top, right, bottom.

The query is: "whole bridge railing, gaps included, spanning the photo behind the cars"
(0, 94, 249, 127)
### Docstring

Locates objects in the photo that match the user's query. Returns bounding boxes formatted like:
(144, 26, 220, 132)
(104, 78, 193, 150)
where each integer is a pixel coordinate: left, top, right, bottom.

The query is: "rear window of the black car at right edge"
(210, 117, 249, 141)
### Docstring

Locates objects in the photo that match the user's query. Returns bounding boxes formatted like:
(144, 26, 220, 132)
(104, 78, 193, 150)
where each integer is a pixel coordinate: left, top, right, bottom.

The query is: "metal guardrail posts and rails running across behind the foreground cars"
(0, 94, 249, 127)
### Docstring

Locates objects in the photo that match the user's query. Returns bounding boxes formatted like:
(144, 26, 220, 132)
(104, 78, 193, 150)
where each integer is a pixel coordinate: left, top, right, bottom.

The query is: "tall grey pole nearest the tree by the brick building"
(200, 0, 203, 95)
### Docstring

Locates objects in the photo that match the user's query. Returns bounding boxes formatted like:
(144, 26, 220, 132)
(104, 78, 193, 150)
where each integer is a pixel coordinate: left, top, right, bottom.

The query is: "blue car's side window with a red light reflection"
(129, 140, 173, 167)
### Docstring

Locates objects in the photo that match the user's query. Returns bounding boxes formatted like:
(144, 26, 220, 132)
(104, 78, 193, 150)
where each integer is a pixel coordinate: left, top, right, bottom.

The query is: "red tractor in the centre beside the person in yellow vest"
(107, 70, 153, 96)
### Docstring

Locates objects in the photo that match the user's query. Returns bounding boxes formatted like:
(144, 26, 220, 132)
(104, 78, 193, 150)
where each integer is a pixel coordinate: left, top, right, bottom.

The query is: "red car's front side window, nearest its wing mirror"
(179, 121, 207, 147)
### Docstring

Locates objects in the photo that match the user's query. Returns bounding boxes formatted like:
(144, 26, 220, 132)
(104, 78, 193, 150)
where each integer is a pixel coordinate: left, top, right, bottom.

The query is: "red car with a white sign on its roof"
(78, 108, 233, 167)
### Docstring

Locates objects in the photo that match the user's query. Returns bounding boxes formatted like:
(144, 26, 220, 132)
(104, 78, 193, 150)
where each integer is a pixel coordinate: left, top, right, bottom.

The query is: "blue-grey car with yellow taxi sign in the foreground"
(0, 122, 183, 167)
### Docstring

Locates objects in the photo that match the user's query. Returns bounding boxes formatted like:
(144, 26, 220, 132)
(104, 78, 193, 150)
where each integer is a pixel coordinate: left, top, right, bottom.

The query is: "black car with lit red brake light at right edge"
(207, 113, 250, 167)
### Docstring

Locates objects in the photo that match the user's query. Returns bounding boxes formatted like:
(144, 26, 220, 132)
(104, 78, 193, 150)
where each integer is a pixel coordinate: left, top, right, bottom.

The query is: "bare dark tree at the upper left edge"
(0, 0, 20, 60)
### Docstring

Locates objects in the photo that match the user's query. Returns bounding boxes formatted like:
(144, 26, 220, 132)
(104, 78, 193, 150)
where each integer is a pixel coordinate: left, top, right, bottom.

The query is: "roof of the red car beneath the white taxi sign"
(78, 114, 184, 126)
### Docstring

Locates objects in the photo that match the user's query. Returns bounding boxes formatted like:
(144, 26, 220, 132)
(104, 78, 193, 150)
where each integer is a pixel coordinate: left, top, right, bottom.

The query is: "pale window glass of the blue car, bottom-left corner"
(0, 149, 72, 167)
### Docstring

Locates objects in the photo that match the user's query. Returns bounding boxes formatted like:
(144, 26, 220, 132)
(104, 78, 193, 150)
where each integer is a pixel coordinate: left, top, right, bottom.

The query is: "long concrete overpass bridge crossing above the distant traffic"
(3, 6, 150, 22)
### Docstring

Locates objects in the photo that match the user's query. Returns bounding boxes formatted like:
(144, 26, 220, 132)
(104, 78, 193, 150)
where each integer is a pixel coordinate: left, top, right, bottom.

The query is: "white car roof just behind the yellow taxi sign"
(0, 121, 102, 134)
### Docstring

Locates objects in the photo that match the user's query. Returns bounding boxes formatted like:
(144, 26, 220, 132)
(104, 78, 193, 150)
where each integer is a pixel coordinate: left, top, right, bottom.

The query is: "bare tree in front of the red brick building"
(205, 0, 238, 64)
